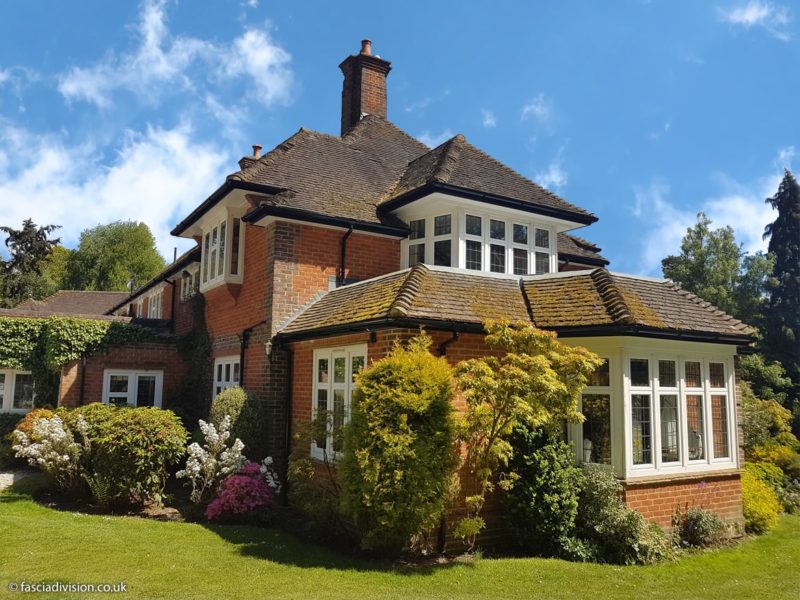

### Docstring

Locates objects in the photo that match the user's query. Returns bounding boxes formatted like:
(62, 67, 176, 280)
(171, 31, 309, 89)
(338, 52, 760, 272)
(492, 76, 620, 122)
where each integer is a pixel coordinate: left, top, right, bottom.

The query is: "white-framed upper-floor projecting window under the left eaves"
(199, 216, 244, 289)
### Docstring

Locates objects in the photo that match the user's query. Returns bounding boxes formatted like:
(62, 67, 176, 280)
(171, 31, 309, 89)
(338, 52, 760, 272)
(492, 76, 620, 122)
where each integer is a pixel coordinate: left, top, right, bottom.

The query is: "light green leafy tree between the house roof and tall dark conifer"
(661, 213, 772, 327)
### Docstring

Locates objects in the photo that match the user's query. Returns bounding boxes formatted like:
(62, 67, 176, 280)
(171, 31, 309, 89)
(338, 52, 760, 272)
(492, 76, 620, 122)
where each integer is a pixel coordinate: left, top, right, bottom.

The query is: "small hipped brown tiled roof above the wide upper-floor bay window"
(386, 134, 593, 221)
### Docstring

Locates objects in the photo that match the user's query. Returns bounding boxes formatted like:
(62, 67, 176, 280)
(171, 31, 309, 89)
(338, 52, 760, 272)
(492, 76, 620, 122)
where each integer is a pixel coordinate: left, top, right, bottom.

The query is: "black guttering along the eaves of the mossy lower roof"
(275, 317, 754, 346)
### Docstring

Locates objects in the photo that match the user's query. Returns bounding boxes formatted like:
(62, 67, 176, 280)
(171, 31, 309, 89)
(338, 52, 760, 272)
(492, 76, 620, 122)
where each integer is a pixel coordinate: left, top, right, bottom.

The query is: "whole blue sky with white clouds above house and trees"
(0, 0, 800, 275)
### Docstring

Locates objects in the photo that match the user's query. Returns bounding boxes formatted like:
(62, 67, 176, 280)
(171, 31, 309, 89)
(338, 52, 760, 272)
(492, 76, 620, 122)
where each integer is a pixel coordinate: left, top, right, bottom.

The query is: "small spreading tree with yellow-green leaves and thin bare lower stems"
(456, 322, 602, 548)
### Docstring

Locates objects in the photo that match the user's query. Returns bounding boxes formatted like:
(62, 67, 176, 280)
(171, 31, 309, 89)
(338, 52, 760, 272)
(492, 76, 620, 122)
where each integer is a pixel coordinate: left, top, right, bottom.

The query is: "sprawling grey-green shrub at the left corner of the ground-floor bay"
(576, 465, 670, 565)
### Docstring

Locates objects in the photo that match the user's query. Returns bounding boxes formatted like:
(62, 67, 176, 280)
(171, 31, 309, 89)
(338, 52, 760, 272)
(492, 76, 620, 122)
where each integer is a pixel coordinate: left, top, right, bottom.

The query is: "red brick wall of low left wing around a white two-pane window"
(58, 341, 186, 407)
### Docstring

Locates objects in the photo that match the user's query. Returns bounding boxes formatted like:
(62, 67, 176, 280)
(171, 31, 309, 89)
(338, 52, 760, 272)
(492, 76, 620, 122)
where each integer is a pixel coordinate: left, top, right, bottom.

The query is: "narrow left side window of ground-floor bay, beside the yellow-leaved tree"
(581, 358, 611, 465)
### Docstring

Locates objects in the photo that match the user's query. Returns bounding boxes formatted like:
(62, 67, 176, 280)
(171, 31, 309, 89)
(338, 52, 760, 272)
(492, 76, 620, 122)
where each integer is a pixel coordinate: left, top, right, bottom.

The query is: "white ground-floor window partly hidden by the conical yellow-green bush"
(311, 344, 367, 460)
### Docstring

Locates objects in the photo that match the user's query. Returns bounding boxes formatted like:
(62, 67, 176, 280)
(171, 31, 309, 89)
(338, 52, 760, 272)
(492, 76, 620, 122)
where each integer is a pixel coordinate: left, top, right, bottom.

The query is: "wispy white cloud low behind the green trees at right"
(633, 155, 780, 275)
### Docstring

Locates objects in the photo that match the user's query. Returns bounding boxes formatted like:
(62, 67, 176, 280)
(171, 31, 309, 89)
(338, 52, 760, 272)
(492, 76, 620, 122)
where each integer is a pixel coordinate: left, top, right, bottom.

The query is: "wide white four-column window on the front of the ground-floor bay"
(626, 356, 735, 470)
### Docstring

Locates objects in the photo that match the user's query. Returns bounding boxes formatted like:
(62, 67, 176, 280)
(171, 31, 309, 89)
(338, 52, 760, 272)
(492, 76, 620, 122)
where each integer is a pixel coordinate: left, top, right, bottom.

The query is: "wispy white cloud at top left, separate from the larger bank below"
(58, 0, 293, 108)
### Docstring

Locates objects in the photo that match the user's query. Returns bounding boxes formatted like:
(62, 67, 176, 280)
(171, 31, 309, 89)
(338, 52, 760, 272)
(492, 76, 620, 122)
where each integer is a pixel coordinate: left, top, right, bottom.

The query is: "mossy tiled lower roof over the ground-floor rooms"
(281, 265, 752, 343)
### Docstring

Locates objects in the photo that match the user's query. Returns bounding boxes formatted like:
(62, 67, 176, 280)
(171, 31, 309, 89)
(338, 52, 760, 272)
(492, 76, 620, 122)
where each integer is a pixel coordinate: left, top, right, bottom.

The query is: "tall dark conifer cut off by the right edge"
(764, 170, 800, 399)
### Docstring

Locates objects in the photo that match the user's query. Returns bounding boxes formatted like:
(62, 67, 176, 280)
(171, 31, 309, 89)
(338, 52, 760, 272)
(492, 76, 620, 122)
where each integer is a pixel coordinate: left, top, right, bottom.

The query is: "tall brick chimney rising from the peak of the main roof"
(339, 40, 392, 135)
